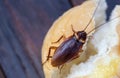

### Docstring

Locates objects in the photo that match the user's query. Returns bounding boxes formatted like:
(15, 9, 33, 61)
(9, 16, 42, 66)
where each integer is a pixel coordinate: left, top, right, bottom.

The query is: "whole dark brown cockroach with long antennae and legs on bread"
(43, 0, 120, 67)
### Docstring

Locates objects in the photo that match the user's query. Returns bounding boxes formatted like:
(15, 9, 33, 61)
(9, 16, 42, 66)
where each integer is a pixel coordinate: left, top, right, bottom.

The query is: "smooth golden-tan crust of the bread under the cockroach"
(42, 1, 96, 78)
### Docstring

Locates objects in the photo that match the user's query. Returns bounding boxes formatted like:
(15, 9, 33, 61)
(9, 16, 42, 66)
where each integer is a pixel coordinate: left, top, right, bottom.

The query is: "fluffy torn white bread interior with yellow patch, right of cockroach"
(67, 6, 120, 78)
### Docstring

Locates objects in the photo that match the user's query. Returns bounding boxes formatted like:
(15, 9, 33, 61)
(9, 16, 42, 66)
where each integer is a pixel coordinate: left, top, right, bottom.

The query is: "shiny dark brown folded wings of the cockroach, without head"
(51, 36, 83, 67)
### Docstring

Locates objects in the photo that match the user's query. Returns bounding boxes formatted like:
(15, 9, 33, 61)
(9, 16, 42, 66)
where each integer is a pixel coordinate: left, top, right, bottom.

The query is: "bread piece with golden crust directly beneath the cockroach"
(42, 0, 107, 78)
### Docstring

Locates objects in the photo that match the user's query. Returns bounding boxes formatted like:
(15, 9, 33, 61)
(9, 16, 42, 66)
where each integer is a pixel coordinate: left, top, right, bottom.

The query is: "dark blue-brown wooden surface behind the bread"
(0, 0, 119, 78)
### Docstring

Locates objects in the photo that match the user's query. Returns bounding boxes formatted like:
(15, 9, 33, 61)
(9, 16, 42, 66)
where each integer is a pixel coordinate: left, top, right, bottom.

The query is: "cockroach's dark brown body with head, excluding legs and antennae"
(51, 31, 87, 67)
